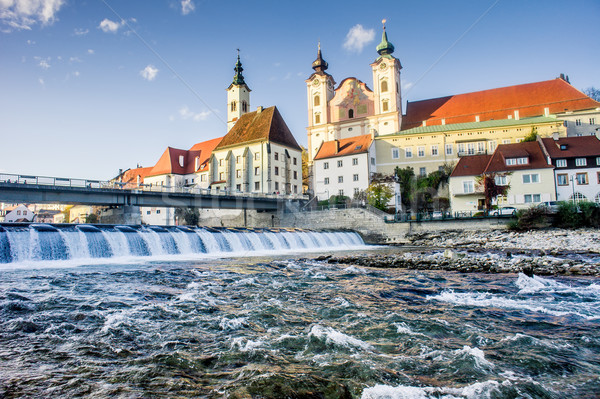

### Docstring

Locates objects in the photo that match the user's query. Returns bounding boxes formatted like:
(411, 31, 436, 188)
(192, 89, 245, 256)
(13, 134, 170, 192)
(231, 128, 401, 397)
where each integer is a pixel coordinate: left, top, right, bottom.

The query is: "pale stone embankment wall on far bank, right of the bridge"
(279, 208, 508, 244)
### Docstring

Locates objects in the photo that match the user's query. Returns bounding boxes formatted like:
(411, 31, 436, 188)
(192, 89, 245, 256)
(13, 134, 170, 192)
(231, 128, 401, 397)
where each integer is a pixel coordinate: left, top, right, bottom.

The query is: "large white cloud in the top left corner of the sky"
(0, 0, 65, 32)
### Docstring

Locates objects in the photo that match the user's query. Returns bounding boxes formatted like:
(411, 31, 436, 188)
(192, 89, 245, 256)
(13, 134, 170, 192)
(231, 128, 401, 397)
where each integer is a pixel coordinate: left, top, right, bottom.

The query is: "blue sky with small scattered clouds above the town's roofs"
(0, 0, 600, 179)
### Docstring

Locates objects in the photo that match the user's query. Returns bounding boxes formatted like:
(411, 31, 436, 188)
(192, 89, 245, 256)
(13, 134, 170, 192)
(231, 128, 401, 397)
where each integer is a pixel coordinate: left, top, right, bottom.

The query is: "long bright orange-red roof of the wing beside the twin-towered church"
(402, 78, 600, 130)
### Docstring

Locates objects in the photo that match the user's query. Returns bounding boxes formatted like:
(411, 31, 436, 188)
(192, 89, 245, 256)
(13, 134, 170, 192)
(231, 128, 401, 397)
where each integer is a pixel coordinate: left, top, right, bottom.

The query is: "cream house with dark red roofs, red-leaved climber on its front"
(448, 141, 556, 213)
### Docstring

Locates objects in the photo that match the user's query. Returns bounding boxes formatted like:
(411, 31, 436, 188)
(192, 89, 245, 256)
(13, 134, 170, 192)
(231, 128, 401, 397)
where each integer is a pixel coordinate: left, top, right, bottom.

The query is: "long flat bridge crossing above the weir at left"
(0, 174, 307, 211)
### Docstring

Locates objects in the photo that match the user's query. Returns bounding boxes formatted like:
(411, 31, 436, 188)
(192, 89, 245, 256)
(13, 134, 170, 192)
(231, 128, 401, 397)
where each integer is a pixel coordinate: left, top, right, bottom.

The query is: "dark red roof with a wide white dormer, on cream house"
(485, 141, 554, 173)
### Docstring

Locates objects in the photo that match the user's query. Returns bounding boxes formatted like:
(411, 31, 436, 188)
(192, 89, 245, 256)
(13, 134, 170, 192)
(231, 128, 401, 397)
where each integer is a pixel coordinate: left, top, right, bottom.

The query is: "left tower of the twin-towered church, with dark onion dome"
(306, 42, 337, 163)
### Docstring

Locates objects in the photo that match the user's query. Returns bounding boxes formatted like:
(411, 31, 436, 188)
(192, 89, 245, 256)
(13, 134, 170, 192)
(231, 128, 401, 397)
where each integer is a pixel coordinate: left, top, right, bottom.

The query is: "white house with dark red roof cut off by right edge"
(540, 136, 600, 203)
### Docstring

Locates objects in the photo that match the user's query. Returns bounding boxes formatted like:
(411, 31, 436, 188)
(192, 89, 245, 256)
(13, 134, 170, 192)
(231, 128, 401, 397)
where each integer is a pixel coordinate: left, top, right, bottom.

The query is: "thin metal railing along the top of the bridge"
(0, 173, 308, 199)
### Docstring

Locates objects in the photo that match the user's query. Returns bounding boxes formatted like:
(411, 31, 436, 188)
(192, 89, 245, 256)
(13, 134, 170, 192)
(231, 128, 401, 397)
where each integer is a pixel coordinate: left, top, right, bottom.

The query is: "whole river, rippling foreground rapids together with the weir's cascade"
(0, 226, 600, 399)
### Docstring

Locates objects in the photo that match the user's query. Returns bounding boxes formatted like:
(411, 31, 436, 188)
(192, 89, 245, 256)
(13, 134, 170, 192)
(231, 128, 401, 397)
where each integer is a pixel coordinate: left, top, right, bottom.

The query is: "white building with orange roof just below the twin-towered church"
(313, 134, 376, 201)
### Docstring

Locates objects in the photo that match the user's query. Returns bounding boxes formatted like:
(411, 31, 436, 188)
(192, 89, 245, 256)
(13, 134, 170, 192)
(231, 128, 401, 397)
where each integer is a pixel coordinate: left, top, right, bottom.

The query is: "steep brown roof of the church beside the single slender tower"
(216, 107, 302, 151)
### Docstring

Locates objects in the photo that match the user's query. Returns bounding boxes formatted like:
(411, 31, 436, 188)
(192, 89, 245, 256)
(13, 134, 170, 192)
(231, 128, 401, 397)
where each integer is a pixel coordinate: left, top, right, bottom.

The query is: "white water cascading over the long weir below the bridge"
(0, 224, 364, 264)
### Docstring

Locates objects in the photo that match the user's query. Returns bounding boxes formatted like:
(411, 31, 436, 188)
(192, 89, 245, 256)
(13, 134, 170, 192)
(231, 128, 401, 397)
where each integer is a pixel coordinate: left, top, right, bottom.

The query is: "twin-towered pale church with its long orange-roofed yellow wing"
(306, 26, 600, 195)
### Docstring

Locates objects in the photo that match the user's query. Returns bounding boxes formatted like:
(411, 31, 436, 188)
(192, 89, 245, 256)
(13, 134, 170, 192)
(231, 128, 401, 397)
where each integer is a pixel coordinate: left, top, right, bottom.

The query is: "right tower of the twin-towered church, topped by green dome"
(371, 19, 402, 134)
